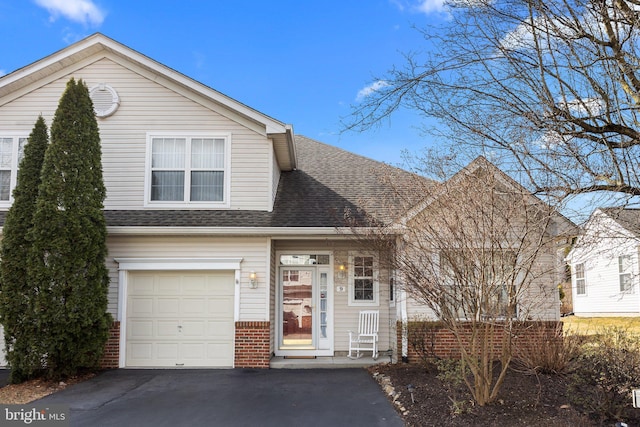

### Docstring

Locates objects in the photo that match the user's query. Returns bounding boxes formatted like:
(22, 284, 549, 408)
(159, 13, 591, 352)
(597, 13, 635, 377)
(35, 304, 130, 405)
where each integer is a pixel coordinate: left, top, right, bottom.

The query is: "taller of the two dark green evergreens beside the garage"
(28, 78, 111, 378)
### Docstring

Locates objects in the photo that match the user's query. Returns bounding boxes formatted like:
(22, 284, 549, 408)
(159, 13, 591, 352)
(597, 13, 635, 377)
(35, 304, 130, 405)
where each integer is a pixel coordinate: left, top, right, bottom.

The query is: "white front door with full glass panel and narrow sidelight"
(277, 258, 333, 356)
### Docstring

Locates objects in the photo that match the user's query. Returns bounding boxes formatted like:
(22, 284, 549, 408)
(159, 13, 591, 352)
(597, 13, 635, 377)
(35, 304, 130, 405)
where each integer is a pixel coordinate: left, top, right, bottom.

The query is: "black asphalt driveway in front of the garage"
(38, 369, 403, 427)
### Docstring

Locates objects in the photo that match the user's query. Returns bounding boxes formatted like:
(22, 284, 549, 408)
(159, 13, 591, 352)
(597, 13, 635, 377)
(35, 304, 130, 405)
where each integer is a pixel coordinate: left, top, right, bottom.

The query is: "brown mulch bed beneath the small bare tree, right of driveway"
(370, 364, 640, 427)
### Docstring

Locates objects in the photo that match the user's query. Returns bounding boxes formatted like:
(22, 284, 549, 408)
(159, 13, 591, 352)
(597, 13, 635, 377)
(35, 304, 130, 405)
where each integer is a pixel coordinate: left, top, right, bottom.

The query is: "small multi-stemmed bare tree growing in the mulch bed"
(356, 158, 569, 405)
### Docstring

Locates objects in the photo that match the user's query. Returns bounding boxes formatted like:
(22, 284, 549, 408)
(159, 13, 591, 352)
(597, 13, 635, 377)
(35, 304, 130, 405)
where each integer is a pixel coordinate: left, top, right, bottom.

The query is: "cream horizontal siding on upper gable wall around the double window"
(0, 56, 273, 211)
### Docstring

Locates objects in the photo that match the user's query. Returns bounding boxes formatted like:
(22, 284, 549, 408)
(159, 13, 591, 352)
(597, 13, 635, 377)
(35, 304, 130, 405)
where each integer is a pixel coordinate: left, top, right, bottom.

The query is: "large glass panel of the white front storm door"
(280, 267, 315, 349)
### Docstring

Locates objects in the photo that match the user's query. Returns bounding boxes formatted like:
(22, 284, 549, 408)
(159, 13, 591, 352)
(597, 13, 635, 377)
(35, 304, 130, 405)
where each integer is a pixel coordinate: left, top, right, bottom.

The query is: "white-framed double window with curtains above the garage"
(146, 135, 230, 207)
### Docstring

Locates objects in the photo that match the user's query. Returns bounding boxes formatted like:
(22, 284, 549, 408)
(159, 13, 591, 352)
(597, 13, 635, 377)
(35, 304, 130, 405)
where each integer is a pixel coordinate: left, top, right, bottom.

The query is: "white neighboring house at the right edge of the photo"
(567, 208, 640, 316)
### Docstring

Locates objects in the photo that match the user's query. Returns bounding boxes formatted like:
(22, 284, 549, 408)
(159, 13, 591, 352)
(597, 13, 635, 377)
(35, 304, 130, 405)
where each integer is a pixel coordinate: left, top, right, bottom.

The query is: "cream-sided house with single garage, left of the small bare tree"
(0, 34, 558, 367)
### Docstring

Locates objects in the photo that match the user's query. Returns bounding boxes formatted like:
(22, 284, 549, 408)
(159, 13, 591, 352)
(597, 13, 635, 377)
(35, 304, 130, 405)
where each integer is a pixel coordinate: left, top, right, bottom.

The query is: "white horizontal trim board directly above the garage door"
(114, 258, 242, 271)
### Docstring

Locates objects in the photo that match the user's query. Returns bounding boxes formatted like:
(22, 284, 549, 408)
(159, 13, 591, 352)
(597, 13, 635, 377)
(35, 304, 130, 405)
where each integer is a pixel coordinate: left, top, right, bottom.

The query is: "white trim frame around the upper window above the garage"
(144, 132, 231, 209)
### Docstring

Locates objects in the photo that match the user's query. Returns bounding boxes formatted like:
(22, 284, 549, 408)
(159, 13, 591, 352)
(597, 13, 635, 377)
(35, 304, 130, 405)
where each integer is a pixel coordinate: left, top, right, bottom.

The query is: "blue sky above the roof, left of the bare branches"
(0, 0, 446, 164)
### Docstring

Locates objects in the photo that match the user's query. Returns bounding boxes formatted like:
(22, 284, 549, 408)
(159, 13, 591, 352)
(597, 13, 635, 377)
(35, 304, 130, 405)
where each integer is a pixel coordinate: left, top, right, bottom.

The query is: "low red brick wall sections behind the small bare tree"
(397, 321, 562, 363)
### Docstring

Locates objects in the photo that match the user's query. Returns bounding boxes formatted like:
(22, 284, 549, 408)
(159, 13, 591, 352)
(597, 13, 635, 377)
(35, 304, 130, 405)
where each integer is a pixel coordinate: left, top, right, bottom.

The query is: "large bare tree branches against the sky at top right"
(346, 0, 640, 214)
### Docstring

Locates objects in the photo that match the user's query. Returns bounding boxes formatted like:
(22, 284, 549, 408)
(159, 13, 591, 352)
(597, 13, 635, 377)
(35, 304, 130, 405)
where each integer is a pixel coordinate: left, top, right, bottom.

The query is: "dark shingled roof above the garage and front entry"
(0, 136, 423, 228)
